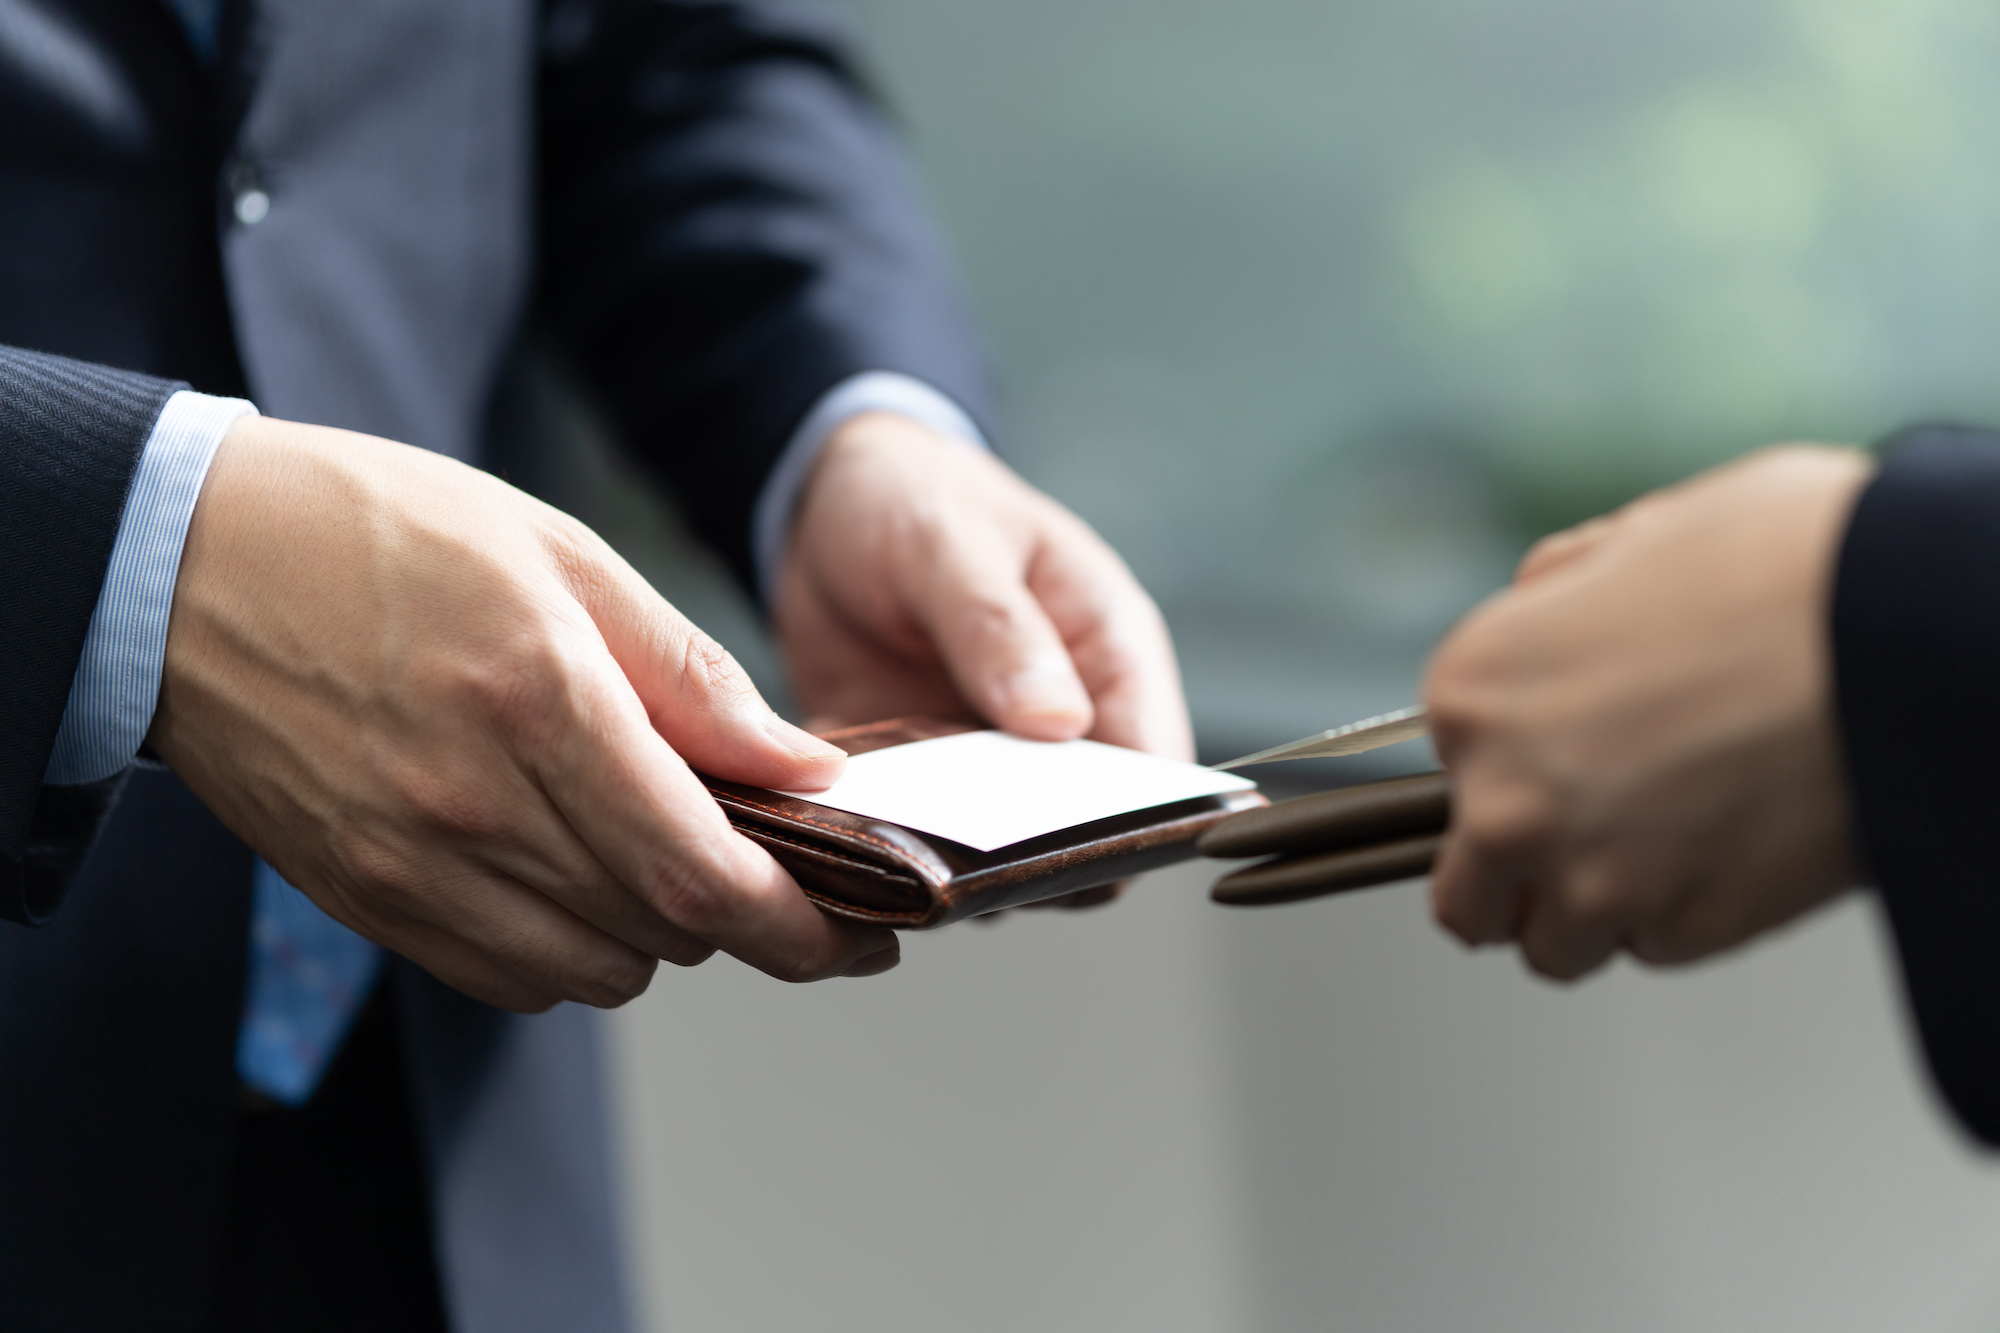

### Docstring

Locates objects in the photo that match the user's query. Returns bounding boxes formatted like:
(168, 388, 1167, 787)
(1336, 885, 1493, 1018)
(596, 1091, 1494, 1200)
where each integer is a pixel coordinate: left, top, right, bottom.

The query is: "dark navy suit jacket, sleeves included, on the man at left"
(0, 0, 982, 1333)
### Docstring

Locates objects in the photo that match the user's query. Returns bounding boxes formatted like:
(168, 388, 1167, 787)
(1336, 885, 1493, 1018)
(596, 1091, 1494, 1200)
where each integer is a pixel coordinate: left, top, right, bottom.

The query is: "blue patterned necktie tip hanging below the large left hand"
(236, 861, 382, 1107)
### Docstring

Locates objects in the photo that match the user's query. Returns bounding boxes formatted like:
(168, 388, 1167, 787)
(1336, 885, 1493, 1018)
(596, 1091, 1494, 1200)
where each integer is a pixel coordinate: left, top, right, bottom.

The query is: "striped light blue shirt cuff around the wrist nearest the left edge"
(42, 390, 256, 785)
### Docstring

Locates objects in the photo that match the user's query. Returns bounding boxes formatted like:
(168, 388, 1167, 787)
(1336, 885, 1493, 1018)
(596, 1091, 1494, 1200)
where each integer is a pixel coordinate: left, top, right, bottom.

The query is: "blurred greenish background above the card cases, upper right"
(836, 0, 2000, 757)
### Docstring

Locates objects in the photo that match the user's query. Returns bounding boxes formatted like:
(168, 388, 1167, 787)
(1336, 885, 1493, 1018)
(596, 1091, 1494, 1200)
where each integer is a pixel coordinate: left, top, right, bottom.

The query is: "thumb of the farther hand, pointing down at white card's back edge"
(918, 536, 1096, 741)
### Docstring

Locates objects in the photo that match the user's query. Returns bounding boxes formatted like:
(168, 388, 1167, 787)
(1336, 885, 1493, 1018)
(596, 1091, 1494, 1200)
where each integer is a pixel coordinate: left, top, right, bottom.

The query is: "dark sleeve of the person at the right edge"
(1832, 428, 2000, 1145)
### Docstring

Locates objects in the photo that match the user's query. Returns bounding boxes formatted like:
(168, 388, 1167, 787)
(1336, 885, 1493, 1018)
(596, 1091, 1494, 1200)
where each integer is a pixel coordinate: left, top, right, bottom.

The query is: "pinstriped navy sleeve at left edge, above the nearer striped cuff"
(0, 348, 180, 925)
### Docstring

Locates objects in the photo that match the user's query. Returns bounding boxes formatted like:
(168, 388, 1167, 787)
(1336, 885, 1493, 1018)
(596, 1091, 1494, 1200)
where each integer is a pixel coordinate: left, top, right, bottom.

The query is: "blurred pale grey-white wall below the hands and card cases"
(614, 869, 2000, 1333)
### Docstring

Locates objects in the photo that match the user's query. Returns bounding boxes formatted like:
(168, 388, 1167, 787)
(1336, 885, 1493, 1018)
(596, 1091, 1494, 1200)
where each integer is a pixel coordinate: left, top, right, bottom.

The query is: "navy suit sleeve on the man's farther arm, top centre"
(540, 0, 986, 588)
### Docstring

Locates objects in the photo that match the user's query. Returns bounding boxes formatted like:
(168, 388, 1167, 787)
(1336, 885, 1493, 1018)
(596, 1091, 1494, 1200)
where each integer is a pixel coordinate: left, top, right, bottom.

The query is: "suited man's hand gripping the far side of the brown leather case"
(774, 412, 1194, 907)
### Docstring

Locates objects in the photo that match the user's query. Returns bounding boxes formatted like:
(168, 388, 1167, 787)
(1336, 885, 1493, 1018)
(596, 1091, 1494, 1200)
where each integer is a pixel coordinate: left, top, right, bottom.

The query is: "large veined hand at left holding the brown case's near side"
(148, 416, 896, 1011)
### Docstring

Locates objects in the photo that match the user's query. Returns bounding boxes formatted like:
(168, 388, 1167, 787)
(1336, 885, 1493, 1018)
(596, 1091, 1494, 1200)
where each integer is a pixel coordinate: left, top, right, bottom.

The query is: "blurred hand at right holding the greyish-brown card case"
(1426, 446, 1870, 979)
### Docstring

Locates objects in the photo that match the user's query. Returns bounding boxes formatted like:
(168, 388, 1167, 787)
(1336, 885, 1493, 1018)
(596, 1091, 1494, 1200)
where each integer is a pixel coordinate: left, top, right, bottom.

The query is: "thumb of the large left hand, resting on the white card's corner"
(578, 542, 848, 791)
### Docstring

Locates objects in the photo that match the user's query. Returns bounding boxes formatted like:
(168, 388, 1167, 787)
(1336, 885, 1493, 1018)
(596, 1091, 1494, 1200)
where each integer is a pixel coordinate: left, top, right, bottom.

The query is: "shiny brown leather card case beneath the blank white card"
(702, 719, 1270, 931)
